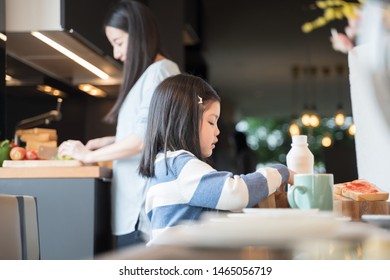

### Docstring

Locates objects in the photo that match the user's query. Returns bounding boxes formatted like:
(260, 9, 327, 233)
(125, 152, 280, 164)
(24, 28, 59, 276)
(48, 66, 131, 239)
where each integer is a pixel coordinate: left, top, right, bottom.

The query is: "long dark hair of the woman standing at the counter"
(104, 0, 162, 123)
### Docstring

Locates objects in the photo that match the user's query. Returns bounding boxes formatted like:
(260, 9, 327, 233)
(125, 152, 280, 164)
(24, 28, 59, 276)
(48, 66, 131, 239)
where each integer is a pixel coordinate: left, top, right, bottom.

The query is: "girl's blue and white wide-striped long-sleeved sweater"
(145, 150, 289, 241)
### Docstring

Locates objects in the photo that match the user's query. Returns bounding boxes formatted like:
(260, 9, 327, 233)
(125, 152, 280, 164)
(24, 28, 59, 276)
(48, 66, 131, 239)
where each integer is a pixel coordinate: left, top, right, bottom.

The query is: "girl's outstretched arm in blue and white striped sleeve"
(178, 155, 290, 210)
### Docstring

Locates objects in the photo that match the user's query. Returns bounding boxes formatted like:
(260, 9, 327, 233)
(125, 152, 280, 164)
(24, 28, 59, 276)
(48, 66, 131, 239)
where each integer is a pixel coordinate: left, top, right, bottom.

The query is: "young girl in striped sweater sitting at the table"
(140, 74, 293, 242)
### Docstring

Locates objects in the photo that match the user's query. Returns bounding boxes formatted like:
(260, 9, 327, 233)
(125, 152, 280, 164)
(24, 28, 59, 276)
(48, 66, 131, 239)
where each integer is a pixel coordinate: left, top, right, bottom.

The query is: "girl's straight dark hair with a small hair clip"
(139, 74, 221, 177)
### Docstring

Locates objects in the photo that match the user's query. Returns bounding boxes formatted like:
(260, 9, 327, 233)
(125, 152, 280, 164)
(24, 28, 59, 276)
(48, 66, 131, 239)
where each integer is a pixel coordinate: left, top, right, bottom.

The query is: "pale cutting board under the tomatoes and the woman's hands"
(3, 160, 83, 168)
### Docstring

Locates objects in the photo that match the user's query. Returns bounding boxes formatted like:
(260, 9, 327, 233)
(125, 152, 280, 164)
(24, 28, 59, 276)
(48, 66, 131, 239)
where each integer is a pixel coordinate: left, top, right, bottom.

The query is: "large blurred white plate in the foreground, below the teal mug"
(153, 211, 340, 248)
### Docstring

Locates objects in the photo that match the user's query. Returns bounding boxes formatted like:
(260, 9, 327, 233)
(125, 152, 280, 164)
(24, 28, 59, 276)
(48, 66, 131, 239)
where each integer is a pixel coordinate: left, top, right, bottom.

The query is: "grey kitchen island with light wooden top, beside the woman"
(0, 166, 112, 260)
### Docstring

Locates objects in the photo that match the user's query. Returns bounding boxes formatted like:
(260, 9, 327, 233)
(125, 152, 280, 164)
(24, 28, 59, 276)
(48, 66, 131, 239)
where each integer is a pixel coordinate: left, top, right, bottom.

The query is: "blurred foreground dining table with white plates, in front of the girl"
(97, 197, 390, 260)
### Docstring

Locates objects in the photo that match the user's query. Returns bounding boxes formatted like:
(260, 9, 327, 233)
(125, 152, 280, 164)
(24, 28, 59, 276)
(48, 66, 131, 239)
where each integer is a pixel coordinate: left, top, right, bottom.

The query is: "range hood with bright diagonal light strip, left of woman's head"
(6, 0, 122, 86)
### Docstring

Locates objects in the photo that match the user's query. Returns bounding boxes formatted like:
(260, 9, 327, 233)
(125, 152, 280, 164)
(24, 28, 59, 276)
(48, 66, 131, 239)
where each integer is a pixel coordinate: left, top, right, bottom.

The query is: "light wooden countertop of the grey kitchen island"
(0, 165, 112, 179)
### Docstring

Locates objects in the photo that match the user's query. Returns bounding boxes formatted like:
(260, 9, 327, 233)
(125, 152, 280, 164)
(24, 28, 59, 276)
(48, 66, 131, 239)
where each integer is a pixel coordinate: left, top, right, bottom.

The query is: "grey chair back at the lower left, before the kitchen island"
(0, 194, 40, 260)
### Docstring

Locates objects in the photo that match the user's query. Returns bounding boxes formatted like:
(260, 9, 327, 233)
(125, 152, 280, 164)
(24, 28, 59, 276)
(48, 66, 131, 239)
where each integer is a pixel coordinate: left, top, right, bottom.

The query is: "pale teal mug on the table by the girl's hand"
(287, 174, 334, 211)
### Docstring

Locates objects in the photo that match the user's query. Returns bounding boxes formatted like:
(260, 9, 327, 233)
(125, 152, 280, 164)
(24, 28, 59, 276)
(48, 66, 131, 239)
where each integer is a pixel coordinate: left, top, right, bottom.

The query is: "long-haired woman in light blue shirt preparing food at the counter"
(59, 0, 180, 248)
